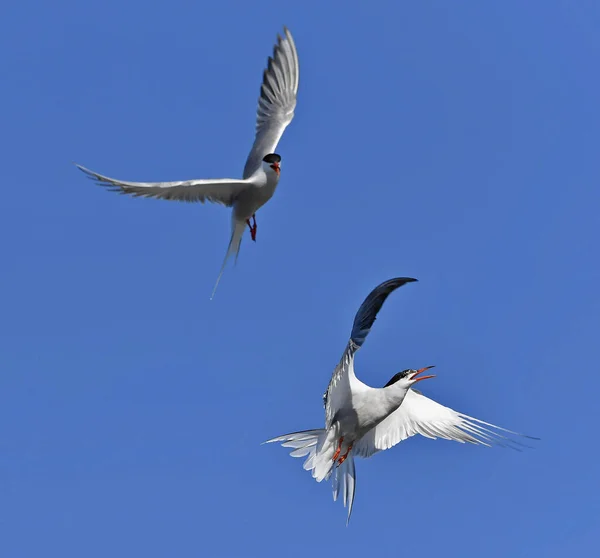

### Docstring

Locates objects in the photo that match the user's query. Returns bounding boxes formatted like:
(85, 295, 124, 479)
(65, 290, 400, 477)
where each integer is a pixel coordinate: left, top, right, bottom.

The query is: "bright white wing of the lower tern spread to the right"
(353, 389, 535, 457)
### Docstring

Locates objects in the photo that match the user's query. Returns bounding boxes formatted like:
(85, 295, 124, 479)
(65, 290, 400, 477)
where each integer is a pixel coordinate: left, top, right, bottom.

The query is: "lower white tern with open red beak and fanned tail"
(265, 277, 531, 524)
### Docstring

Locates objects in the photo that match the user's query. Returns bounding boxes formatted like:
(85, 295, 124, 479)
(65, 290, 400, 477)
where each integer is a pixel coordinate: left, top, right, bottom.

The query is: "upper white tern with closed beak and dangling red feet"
(76, 27, 300, 298)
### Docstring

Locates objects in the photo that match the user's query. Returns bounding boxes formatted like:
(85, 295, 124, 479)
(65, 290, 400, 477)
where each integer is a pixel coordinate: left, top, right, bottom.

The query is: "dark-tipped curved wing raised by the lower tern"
(323, 277, 416, 428)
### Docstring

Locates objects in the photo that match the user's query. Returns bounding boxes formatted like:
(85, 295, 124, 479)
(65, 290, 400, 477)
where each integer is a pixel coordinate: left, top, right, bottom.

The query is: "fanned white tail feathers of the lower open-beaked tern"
(264, 428, 356, 525)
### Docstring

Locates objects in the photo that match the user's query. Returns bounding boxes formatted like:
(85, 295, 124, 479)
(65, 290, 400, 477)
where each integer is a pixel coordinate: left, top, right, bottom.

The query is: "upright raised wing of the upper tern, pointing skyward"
(243, 27, 300, 178)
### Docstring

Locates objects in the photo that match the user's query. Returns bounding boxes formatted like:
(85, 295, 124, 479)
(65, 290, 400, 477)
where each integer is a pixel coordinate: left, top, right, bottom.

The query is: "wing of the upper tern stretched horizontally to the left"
(75, 165, 251, 206)
